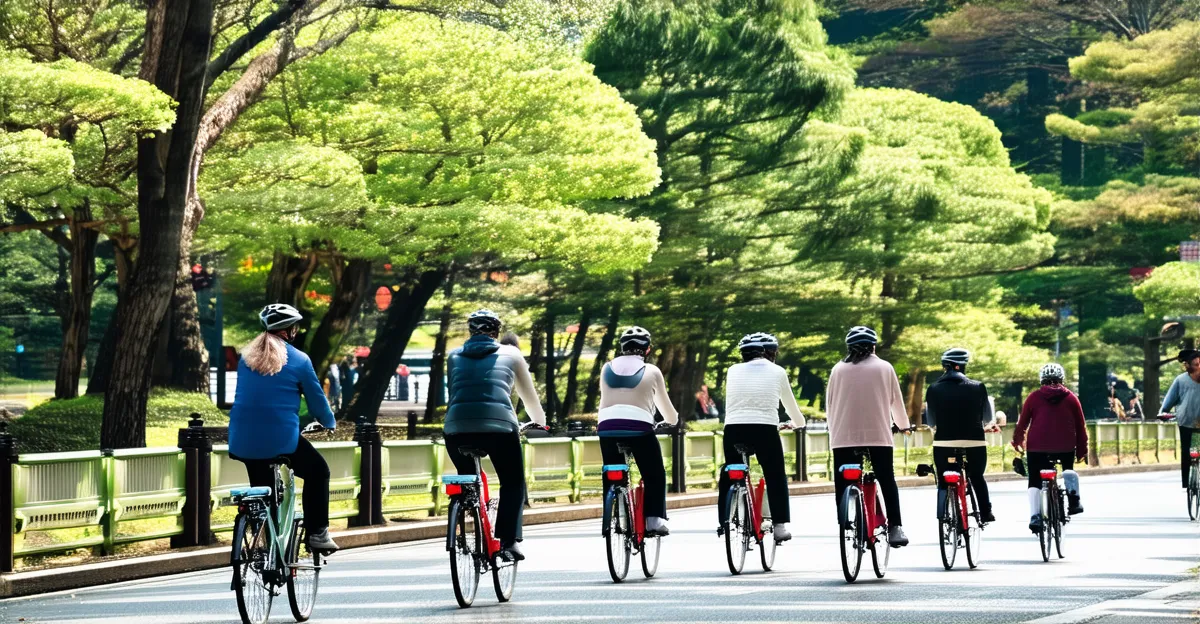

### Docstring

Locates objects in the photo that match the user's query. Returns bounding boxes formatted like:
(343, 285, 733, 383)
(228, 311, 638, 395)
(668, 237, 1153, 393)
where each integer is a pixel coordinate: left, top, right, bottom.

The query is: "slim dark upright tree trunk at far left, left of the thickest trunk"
(54, 202, 100, 398)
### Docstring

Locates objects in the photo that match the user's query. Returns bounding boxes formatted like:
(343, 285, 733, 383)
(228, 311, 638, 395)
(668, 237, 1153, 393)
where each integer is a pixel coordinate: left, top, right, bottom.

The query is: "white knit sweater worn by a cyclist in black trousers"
(725, 358, 804, 427)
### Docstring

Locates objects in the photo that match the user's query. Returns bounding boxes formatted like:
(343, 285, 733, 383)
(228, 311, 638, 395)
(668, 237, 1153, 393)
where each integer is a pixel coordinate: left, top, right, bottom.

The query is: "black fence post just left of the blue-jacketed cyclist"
(170, 414, 216, 548)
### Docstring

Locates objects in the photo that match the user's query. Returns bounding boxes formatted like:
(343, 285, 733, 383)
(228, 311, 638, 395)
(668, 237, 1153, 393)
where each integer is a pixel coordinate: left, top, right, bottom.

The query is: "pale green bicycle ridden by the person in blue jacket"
(229, 425, 325, 624)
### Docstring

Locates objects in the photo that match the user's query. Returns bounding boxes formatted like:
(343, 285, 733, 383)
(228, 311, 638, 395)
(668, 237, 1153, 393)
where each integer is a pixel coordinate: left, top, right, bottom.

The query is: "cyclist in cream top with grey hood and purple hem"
(596, 325, 679, 536)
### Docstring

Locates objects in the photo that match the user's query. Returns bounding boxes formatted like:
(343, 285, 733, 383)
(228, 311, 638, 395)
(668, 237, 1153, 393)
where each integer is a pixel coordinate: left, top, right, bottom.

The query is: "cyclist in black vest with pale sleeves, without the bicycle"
(925, 348, 996, 522)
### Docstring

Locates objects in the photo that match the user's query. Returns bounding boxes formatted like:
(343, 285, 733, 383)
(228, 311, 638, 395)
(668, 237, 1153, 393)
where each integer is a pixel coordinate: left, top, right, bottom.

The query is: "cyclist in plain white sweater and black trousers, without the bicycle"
(716, 332, 804, 541)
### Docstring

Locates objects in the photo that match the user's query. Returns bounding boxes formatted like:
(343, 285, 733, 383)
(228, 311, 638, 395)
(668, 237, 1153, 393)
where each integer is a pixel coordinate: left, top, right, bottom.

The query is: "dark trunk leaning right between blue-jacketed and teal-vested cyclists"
(338, 268, 449, 422)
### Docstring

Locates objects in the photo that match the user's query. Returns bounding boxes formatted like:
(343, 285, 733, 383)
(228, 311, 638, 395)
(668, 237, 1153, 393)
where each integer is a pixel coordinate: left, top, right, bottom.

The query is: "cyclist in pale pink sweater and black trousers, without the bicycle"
(826, 325, 908, 547)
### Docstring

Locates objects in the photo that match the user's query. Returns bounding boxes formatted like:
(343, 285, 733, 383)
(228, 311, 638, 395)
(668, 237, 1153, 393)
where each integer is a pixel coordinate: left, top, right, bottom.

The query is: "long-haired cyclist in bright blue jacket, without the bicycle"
(229, 304, 337, 553)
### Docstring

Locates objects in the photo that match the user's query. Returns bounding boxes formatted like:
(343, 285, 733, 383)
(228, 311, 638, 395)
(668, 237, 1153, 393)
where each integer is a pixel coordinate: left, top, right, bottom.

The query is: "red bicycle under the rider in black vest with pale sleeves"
(917, 449, 988, 570)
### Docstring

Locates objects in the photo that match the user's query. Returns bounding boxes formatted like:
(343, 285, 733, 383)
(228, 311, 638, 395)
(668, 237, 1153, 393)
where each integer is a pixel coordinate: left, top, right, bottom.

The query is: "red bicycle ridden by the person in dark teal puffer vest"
(442, 422, 545, 608)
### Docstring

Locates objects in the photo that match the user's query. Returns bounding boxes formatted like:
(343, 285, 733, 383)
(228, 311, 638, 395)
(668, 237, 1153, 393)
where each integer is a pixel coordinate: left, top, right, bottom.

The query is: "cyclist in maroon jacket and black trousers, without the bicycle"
(1013, 362, 1087, 533)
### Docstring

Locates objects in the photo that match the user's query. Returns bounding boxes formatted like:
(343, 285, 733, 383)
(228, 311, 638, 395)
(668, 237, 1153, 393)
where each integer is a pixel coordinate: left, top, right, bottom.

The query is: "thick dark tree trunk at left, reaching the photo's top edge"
(100, 0, 214, 449)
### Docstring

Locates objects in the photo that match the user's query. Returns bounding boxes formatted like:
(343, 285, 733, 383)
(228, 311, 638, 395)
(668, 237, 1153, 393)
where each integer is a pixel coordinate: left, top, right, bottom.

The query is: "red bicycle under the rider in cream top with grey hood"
(600, 442, 662, 583)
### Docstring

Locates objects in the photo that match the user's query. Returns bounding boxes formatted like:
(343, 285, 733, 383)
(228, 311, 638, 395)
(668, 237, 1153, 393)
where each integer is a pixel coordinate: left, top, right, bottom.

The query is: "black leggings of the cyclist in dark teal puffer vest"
(445, 431, 526, 546)
